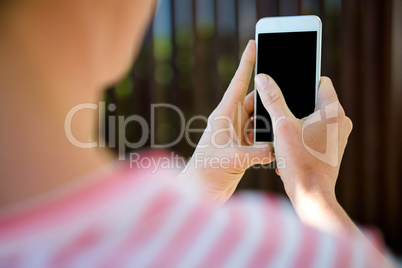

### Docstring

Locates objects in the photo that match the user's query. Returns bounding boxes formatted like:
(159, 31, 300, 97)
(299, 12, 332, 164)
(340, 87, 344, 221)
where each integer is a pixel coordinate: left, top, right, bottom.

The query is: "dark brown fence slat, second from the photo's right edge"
(362, 0, 388, 222)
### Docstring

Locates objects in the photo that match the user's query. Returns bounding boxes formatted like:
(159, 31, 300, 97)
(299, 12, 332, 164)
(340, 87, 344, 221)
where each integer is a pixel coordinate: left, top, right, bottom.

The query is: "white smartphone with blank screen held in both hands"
(254, 16, 321, 143)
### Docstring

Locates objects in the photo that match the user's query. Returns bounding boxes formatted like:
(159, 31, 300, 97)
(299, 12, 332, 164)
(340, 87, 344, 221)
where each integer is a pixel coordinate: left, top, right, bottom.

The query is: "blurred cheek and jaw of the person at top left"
(0, 0, 156, 88)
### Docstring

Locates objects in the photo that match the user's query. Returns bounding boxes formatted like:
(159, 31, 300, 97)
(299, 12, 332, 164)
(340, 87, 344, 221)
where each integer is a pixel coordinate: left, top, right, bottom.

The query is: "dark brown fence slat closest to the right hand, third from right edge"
(337, 0, 364, 222)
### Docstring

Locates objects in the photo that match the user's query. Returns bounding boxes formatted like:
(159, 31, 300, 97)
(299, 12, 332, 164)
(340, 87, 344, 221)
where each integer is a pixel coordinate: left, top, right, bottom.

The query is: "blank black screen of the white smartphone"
(255, 31, 317, 142)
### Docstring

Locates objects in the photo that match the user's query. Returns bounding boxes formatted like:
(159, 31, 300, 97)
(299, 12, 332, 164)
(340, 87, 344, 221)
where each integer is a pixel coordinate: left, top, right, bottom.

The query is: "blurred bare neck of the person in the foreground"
(0, 44, 116, 207)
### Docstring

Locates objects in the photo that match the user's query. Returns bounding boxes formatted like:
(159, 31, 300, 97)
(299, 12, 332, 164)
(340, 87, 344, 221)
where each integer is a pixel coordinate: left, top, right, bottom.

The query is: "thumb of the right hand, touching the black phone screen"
(255, 74, 293, 118)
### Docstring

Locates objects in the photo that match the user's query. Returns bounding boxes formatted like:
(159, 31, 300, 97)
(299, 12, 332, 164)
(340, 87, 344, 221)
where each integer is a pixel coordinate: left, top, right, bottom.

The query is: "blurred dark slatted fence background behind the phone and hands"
(106, 0, 402, 254)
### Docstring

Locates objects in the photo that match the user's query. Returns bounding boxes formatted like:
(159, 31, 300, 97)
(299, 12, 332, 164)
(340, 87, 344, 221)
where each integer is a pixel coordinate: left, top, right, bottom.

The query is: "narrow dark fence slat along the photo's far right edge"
(385, 0, 402, 254)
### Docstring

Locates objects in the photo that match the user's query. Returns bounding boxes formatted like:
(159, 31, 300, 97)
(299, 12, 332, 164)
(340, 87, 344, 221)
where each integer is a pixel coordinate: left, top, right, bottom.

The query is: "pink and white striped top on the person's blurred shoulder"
(0, 152, 390, 268)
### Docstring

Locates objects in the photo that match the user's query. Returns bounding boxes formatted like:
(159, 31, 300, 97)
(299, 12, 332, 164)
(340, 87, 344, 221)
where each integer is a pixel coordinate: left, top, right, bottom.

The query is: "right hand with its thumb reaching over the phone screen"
(255, 74, 355, 230)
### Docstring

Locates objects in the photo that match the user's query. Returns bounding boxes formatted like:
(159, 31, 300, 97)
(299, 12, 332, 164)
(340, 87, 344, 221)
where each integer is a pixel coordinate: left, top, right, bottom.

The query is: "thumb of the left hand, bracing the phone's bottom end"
(237, 144, 275, 169)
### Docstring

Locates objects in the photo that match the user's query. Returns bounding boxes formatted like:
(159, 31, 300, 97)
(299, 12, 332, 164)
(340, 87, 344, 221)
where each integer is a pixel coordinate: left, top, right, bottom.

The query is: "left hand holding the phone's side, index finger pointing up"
(180, 41, 274, 203)
